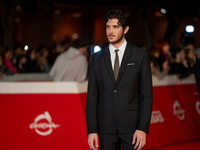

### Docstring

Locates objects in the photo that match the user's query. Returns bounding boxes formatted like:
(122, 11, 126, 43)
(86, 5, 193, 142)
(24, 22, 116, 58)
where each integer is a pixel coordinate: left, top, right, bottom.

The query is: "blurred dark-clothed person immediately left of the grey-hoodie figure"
(37, 45, 51, 72)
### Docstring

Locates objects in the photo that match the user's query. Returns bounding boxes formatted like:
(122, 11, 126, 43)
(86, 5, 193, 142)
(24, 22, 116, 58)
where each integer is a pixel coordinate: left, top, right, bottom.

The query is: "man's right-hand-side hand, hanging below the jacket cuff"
(132, 130, 146, 150)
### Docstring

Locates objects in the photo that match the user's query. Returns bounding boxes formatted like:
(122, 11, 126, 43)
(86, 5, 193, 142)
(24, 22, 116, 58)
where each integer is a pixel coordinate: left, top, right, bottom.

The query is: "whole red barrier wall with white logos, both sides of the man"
(0, 75, 200, 150)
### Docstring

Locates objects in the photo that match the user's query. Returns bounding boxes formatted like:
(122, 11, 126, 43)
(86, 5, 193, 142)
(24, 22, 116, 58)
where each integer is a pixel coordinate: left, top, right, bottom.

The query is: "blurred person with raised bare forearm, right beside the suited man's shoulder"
(149, 46, 169, 79)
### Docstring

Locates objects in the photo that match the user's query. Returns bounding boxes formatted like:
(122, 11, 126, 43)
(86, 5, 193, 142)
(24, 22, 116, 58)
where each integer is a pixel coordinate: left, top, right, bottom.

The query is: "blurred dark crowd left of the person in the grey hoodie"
(0, 37, 70, 78)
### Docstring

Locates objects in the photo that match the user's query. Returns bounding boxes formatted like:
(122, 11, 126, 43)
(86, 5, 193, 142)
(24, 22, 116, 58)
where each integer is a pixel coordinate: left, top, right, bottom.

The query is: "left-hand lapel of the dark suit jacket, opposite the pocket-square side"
(103, 47, 115, 83)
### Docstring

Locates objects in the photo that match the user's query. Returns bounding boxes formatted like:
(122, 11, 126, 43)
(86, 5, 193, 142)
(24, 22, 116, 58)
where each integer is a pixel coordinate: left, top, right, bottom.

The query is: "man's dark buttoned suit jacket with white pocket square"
(86, 43, 152, 134)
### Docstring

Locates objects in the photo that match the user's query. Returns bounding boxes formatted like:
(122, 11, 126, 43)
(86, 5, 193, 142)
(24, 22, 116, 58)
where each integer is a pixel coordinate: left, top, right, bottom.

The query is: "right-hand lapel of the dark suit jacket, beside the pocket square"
(115, 43, 132, 86)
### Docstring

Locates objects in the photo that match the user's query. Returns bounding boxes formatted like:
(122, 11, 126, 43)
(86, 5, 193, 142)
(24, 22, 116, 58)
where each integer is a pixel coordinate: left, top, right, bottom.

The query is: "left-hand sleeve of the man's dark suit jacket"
(86, 55, 99, 135)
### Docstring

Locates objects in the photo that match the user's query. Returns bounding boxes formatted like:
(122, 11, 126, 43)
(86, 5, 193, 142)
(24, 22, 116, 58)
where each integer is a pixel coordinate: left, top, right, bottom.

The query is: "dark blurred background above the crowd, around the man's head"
(0, 0, 200, 48)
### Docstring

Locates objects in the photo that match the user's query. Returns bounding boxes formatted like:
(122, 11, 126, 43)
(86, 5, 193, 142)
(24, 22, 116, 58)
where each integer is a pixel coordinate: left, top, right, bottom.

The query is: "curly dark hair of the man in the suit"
(104, 9, 129, 30)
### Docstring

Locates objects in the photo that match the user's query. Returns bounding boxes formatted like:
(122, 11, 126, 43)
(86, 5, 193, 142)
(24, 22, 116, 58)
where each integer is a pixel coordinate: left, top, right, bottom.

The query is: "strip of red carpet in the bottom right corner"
(148, 140, 200, 150)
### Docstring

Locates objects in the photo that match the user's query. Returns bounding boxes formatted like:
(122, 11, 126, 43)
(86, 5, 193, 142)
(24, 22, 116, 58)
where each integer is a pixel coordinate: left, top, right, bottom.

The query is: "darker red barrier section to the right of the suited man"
(145, 84, 200, 148)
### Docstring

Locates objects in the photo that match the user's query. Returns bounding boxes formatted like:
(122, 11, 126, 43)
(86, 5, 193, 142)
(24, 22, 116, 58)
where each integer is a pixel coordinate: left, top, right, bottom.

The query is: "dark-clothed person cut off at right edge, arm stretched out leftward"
(179, 49, 200, 96)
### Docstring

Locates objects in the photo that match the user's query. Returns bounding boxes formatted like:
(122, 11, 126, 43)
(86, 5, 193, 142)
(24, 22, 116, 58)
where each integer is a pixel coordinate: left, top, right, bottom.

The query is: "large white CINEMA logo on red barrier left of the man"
(29, 111, 60, 136)
